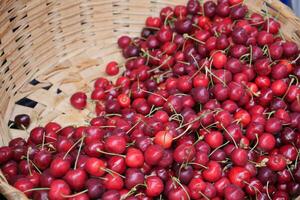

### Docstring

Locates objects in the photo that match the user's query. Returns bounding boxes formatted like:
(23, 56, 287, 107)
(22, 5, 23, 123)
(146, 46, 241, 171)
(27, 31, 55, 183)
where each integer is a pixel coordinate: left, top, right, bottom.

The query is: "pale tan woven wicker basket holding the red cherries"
(0, 0, 300, 199)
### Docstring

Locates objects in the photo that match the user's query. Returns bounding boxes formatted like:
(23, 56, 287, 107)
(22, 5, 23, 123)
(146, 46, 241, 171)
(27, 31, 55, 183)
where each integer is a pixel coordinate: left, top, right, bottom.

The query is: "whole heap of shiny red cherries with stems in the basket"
(0, 0, 300, 200)
